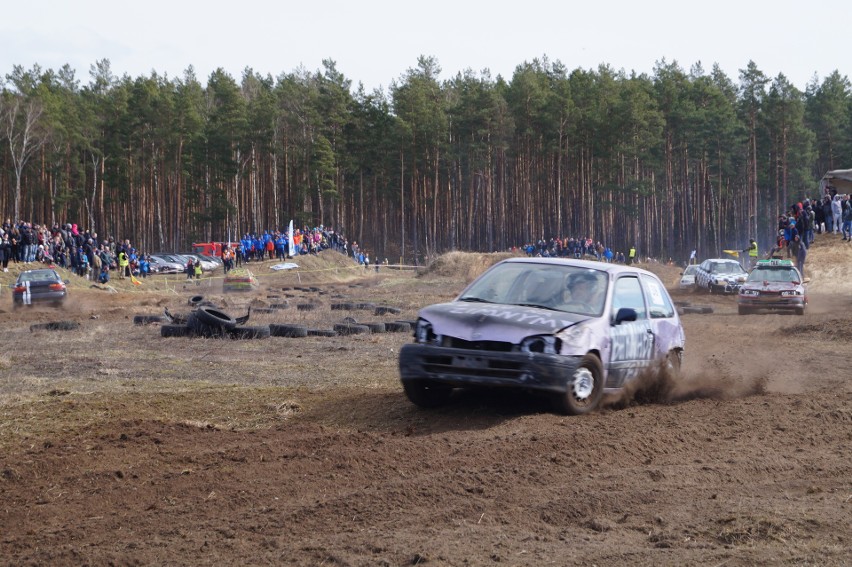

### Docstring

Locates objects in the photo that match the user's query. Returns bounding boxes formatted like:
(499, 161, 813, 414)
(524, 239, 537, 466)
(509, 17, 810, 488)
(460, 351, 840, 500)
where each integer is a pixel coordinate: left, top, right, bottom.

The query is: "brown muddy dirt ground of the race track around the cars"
(0, 241, 852, 566)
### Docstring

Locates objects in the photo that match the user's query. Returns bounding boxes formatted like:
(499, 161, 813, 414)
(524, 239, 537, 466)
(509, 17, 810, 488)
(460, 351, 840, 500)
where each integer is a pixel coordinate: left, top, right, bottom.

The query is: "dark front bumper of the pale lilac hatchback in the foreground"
(399, 344, 580, 393)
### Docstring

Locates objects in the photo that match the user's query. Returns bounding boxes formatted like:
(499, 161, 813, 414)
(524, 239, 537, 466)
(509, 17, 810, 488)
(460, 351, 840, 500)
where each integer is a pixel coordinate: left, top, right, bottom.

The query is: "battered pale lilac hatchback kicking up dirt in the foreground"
(399, 258, 685, 414)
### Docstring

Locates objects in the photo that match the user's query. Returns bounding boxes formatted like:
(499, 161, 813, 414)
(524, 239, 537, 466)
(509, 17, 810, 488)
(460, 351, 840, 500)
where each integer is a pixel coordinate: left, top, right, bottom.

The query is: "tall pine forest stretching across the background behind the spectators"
(0, 56, 852, 263)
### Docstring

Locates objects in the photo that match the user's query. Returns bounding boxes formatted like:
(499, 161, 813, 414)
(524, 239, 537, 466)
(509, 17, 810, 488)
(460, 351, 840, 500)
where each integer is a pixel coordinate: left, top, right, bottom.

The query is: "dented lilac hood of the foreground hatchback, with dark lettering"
(420, 301, 589, 344)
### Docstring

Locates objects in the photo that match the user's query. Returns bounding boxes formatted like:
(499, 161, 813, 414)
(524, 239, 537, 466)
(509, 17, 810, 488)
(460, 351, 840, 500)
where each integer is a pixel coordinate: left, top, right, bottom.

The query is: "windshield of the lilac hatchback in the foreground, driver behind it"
(459, 262, 607, 315)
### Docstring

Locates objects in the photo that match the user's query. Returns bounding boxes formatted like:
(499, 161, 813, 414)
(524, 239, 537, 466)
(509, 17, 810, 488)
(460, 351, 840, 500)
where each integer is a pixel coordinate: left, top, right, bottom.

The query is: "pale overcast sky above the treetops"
(0, 0, 852, 91)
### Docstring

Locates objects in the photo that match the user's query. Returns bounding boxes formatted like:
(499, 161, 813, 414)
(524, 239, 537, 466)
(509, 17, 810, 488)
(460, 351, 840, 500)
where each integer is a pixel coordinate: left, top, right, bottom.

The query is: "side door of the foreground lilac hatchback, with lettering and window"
(606, 274, 654, 388)
